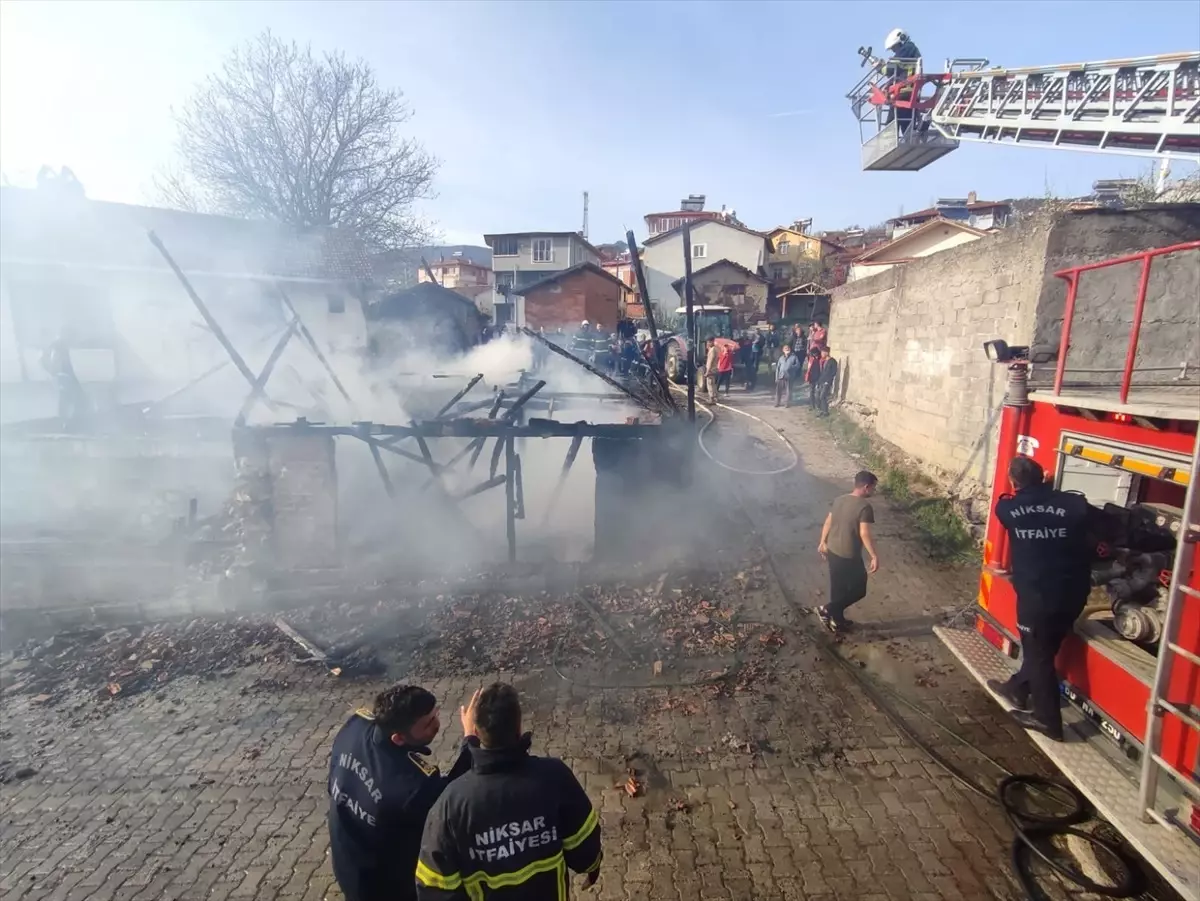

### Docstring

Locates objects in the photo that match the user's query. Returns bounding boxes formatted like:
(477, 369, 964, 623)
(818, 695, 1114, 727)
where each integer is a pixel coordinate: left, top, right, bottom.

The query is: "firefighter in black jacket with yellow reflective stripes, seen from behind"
(416, 683, 602, 901)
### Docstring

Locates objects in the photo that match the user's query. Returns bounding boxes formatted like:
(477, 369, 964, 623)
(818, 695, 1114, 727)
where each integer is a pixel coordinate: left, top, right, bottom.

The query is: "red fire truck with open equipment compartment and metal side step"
(935, 241, 1200, 899)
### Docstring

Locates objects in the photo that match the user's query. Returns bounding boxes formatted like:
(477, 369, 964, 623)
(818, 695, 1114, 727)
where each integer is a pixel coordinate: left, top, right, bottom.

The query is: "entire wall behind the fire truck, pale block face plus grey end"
(829, 204, 1200, 492)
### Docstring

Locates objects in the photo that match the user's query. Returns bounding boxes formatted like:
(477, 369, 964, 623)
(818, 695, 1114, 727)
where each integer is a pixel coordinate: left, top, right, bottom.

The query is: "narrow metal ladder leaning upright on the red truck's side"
(1138, 437, 1200, 822)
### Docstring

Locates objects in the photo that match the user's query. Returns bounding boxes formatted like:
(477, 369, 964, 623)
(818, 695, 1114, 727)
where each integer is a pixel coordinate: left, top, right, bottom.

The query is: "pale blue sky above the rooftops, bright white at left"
(0, 0, 1200, 244)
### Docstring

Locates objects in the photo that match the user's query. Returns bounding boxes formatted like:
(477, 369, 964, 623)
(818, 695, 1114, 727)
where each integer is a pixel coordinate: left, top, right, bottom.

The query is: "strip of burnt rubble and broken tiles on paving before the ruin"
(0, 567, 791, 719)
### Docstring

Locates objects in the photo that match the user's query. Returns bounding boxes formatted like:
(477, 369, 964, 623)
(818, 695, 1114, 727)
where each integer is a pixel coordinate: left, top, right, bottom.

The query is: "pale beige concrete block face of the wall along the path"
(829, 217, 1049, 488)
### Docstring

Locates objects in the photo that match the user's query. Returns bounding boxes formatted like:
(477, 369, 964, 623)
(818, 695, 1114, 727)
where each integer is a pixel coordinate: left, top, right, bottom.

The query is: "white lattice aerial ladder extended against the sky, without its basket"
(931, 52, 1200, 160)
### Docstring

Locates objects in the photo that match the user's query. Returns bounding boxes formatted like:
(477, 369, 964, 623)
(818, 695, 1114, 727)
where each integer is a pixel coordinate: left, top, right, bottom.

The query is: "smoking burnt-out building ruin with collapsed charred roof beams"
(0, 212, 695, 643)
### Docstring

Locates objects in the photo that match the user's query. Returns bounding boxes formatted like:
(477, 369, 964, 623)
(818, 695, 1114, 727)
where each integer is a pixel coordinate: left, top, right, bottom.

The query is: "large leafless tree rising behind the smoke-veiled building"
(157, 31, 438, 250)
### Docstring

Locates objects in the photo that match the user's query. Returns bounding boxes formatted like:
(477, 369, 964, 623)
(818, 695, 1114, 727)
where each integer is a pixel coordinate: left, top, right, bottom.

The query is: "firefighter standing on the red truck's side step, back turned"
(988, 456, 1092, 741)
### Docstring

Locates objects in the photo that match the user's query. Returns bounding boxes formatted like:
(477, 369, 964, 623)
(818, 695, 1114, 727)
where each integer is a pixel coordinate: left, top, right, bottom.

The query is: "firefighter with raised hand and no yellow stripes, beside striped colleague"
(329, 685, 479, 901)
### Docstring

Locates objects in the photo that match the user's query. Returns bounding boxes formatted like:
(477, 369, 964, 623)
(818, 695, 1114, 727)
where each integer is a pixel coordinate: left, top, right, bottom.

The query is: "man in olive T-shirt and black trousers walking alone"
(817, 469, 880, 632)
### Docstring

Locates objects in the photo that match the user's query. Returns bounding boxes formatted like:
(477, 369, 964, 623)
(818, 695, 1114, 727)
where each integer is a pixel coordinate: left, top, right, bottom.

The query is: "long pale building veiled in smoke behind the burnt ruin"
(0, 173, 372, 421)
